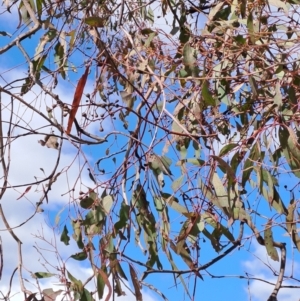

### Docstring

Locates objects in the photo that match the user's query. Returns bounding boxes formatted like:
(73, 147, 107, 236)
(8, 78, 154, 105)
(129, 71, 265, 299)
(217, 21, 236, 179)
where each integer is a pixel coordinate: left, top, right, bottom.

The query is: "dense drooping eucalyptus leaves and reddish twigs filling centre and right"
(0, 0, 300, 300)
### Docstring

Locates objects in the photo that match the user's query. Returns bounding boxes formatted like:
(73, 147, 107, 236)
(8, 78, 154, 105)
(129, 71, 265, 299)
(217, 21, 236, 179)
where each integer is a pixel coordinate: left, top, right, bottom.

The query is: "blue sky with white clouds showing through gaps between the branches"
(0, 2, 300, 301)
